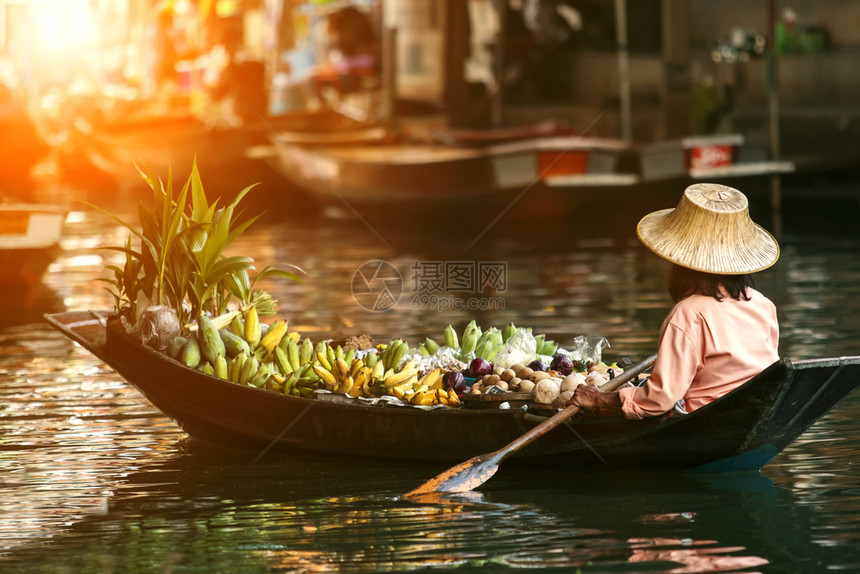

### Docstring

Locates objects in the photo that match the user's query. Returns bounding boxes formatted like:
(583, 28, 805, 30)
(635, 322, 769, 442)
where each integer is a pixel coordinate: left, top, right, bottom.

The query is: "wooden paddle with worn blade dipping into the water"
(404, 354, 657, 498)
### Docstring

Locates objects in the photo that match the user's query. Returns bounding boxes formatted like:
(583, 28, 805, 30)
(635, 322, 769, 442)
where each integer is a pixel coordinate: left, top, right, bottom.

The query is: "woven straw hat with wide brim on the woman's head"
(636, 183, 779, 275)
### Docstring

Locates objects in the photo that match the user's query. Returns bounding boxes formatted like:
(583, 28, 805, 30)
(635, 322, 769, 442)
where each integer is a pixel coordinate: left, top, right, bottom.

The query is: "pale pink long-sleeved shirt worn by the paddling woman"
(619, 289, 779, 419)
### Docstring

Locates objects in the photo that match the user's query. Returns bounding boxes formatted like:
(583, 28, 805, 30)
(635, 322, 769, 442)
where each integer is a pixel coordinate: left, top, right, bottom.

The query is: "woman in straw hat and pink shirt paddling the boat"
(568, 183, 779, 419)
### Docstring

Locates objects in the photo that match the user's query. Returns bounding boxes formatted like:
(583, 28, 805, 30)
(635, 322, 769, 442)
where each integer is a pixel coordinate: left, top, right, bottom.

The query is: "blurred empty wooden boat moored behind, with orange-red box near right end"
(270, 136, 637, 226)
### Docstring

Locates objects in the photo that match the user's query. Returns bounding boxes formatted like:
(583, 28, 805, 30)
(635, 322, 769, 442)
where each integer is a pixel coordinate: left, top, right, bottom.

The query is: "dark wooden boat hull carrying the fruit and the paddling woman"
(46, 312, 860, 471)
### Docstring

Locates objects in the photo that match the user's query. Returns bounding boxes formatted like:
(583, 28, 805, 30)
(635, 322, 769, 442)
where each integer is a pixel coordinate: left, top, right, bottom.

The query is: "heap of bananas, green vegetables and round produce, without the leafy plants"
(165, 312, 620, 407)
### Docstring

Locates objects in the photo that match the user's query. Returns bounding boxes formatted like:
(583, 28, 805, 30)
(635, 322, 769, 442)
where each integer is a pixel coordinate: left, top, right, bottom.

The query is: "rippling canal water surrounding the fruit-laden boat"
(0, 177, 860, 573)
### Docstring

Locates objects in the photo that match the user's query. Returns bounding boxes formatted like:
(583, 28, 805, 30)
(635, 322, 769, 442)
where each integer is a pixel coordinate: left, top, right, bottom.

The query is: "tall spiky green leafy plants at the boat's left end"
(91, 161, 304, 336)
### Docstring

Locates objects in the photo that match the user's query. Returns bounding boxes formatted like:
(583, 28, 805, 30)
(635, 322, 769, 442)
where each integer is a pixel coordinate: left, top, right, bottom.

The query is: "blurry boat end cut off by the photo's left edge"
(0, 200, 66, 287)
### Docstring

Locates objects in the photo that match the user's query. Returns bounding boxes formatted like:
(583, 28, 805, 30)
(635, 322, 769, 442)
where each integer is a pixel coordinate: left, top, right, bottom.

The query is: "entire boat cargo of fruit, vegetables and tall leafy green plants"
(97, 164, 616, 407)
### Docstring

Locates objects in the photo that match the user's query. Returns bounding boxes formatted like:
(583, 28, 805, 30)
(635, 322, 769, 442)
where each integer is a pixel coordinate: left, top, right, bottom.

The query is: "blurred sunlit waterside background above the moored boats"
(0, 0, 860, 200)
